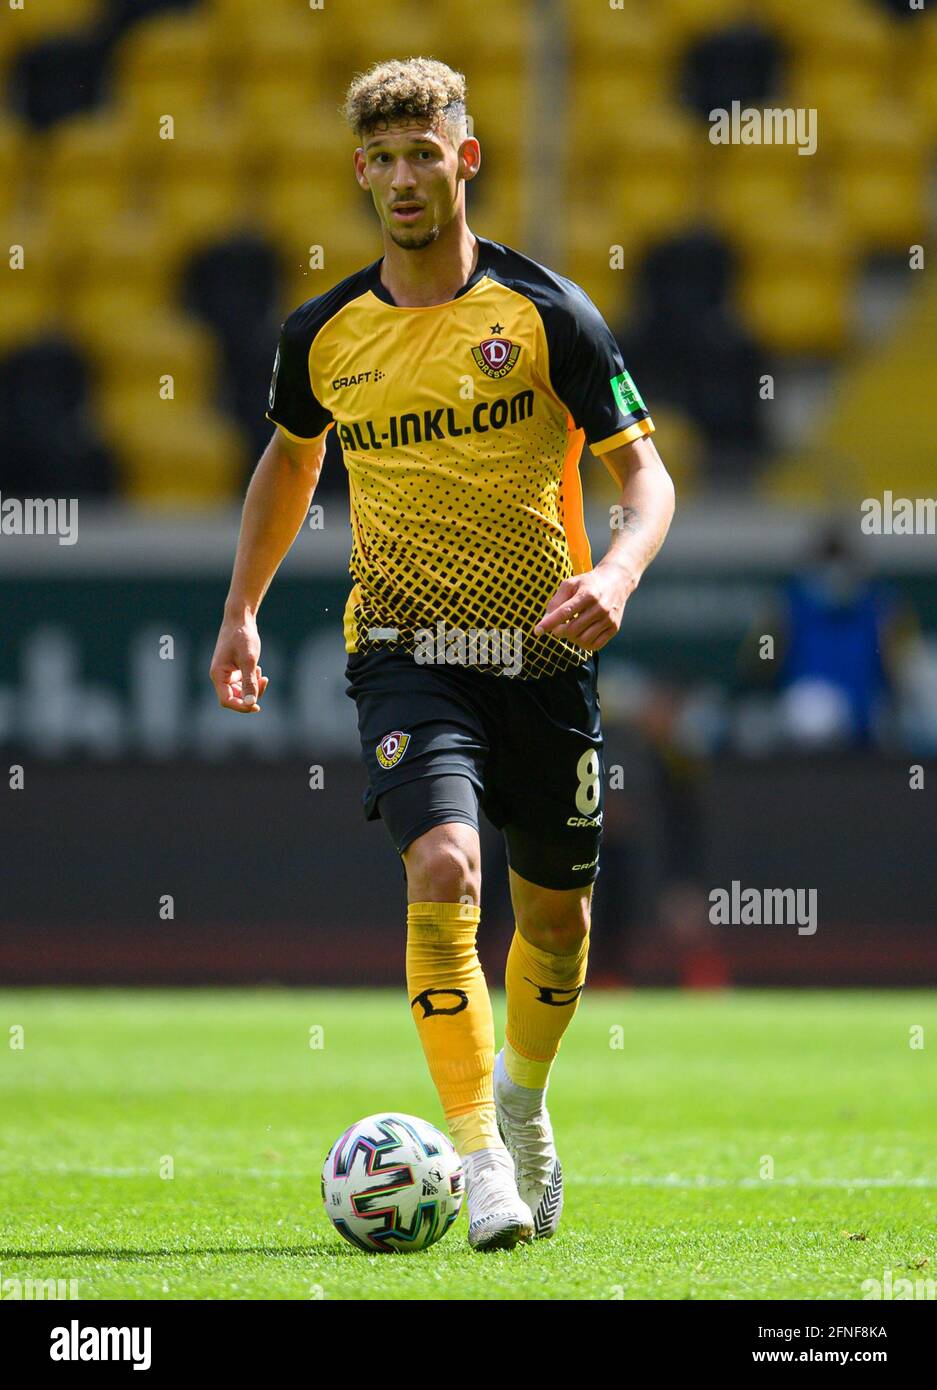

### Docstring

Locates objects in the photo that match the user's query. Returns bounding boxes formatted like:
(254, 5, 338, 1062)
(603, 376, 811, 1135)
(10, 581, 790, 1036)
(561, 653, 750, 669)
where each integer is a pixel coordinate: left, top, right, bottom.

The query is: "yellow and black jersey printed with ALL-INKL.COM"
(267, 236, 653, 677)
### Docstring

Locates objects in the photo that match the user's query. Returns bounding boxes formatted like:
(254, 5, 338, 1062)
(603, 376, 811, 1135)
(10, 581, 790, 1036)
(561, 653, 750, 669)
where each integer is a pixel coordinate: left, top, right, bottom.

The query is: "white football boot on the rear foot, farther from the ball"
(495, 1049, 563, 1240)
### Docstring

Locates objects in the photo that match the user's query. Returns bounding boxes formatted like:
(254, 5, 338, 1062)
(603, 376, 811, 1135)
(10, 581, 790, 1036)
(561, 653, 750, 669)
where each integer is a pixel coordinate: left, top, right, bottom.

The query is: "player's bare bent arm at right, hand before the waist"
(534, 435, 676, 652)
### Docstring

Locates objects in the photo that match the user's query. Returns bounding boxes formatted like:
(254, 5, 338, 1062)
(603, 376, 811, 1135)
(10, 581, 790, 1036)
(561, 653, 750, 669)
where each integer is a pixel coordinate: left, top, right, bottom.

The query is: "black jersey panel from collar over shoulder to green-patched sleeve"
(480, 238, 648, 443)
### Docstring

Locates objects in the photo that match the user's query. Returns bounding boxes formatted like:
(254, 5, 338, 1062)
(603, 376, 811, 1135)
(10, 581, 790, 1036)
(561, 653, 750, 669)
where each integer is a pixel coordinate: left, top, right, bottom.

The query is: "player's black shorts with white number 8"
(345, 648, 605, 888)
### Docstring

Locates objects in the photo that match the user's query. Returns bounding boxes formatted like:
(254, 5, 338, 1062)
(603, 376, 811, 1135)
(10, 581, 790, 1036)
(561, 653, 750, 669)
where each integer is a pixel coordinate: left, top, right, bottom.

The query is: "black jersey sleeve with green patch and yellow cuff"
(544, 281, 653, 455)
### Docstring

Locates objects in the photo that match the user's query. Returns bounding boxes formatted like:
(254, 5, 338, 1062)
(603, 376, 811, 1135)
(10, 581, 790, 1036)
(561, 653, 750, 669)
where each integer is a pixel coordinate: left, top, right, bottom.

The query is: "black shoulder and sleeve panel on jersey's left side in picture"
(266, 261, 380, 439)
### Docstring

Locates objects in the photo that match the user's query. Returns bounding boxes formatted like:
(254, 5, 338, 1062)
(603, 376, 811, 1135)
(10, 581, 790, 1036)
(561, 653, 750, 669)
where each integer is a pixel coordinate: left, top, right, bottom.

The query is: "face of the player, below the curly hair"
(355, 124, 475, 250)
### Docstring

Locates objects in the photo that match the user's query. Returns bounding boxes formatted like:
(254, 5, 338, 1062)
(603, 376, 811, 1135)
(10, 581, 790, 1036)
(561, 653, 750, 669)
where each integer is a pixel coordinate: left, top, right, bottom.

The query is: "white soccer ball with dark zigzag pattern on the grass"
(323, 1112, 464, 1252)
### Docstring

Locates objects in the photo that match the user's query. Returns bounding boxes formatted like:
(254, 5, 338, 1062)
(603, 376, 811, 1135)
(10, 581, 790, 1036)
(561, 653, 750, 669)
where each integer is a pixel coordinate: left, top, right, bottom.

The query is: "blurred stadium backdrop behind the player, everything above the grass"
(0, 0, 937, 987)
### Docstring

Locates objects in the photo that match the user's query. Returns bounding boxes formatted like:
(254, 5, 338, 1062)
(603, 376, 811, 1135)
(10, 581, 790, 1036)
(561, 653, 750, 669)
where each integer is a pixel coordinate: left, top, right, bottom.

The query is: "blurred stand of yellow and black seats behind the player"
(0, 0, 937, 506)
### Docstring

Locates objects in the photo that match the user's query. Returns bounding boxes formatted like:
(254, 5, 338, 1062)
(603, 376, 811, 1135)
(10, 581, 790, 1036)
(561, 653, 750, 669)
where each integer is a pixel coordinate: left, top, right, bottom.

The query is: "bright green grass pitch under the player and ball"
(0, 990, 937, 1300)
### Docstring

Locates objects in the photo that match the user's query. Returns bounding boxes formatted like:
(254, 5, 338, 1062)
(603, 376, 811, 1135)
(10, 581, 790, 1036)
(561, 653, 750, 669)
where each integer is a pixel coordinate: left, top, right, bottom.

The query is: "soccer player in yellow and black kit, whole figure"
(211, 58, 674, 1250)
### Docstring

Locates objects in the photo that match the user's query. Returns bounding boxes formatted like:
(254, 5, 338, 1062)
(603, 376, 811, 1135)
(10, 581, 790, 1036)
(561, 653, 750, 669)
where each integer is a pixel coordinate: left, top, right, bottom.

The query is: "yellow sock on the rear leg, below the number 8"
(505, 927, 589, 1090)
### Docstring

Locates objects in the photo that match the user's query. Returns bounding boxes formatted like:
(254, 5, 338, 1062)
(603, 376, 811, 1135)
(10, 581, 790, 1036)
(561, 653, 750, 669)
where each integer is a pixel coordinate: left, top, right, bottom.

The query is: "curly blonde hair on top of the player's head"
(345, 58, 466, 143)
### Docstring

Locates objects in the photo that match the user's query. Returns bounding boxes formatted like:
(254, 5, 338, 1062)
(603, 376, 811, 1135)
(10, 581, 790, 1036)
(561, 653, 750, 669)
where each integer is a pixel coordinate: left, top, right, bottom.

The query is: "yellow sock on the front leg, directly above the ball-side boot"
(407, 902, 503, 1155)
